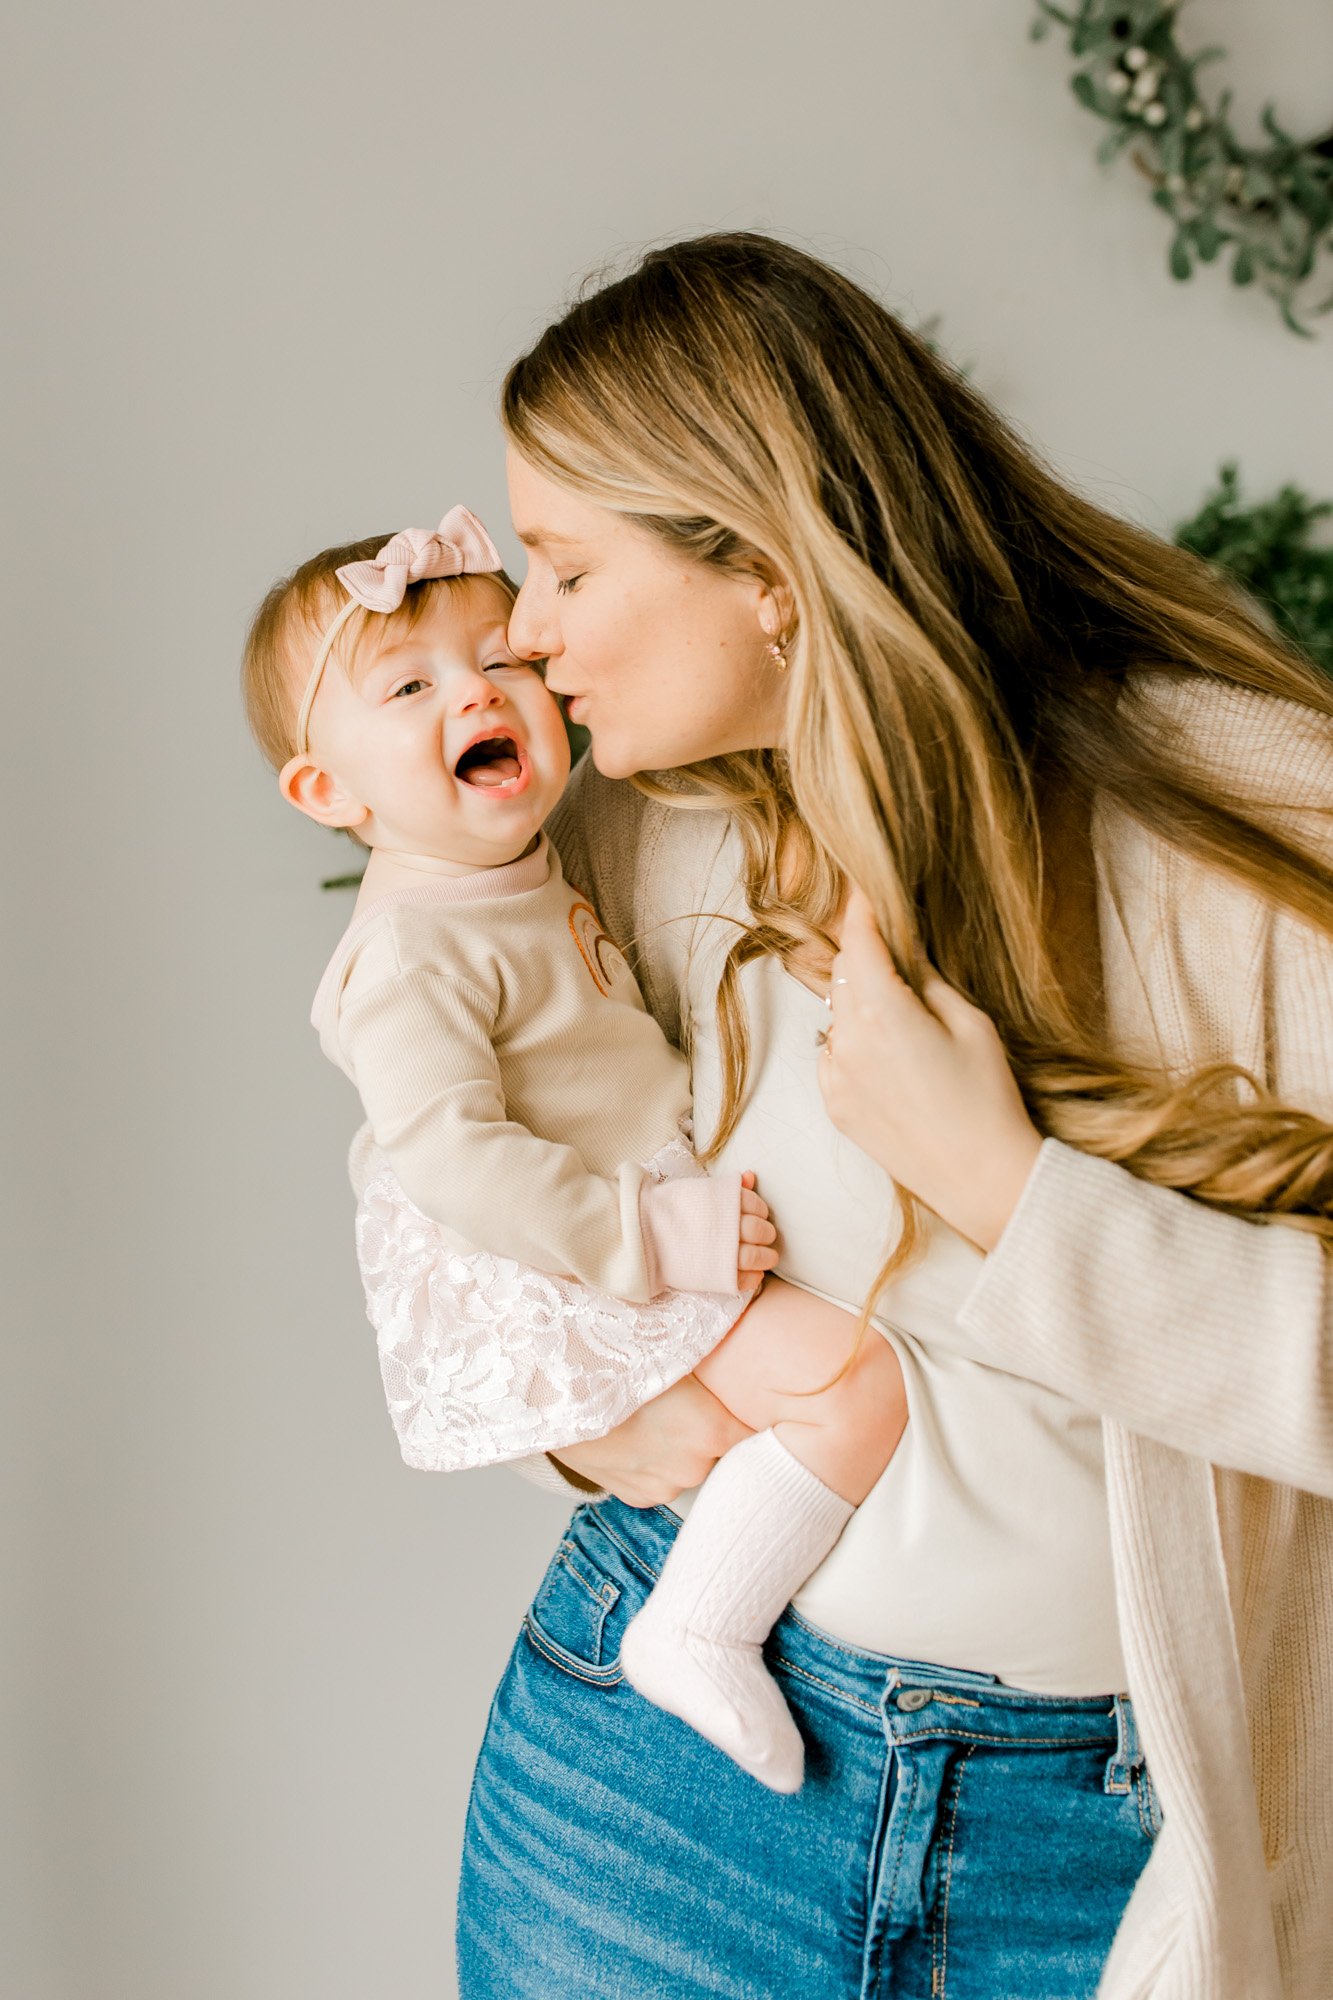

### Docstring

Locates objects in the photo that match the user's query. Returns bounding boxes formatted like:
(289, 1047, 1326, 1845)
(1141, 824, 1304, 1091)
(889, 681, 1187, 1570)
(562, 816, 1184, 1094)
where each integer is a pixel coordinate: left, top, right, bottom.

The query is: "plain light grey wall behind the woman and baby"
(10, 0, 1333, 2000)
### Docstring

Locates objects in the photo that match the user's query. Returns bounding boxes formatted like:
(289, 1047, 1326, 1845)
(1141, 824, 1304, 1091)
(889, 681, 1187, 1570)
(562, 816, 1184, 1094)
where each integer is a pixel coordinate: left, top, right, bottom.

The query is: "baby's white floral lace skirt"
(356, 1140, 745, 1472)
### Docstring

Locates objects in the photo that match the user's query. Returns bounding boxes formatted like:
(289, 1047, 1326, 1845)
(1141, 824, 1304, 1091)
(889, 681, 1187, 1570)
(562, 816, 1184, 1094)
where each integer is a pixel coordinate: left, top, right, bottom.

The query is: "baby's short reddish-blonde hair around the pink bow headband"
(240, 534, 518, 770)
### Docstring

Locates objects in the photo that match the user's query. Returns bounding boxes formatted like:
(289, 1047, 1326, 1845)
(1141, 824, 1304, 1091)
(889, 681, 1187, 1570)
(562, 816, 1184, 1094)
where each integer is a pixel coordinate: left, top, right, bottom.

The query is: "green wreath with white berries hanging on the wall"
(1033, 0, 1333, 336)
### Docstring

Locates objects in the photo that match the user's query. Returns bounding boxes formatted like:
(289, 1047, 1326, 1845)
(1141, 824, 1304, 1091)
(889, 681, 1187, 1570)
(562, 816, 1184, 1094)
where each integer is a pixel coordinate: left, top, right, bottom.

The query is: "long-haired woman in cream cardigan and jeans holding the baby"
(446, 236, 1333, 2000)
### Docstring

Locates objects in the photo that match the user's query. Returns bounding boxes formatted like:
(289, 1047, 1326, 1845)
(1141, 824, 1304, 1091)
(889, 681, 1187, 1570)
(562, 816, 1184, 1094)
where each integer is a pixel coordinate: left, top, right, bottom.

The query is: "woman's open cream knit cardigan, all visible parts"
(528, 676, 1333, 2000)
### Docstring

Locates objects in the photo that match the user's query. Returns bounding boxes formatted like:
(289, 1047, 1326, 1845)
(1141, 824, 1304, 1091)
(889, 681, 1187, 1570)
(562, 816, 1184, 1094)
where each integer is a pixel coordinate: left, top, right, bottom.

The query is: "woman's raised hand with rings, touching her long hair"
(819, 888, 1041, 1250)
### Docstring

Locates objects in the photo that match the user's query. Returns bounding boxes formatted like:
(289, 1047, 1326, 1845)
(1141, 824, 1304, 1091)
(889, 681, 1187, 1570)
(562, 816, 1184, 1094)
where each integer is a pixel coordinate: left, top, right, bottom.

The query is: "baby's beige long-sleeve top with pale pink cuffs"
(310, 838, 741, 1302)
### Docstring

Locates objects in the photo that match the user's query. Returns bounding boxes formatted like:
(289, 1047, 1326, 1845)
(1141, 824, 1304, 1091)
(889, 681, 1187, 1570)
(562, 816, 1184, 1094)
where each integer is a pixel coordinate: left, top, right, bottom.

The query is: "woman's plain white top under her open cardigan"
(683, 834, 1125, 1694)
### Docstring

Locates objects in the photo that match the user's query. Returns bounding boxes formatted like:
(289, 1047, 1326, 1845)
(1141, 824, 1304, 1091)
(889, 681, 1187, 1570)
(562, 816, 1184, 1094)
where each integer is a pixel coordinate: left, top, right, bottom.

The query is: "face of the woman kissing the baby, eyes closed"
(508, 448, 787, 778)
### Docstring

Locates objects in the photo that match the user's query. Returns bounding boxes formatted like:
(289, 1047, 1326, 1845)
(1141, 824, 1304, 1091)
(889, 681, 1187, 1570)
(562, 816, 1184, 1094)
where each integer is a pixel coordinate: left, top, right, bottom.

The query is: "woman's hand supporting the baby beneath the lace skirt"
(550, 1376, 751, 1506)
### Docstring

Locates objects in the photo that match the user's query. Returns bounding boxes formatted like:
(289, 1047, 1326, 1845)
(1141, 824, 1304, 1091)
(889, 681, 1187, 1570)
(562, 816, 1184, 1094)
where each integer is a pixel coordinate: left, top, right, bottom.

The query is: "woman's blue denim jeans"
(458, 1500, 1159, 2000)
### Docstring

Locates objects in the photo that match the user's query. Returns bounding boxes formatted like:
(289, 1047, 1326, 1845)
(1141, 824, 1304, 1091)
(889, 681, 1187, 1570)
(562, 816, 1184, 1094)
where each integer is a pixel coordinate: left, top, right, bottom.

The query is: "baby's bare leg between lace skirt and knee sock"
(695, 1278, 907, 1506)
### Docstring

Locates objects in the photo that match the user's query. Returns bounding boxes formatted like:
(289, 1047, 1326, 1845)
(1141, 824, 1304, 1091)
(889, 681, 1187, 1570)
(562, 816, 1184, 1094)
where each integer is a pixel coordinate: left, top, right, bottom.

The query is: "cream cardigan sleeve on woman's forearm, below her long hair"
(959, 1136, 1333, 1498)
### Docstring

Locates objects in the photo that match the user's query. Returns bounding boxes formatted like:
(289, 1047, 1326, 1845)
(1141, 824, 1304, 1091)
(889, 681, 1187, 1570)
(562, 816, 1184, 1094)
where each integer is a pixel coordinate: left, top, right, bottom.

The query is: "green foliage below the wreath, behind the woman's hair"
(1175, 464, 1333, 674)
